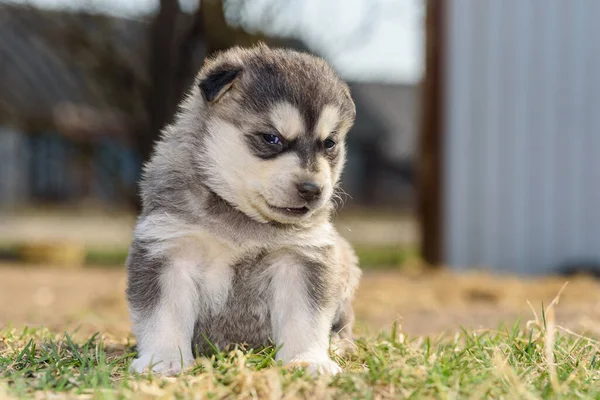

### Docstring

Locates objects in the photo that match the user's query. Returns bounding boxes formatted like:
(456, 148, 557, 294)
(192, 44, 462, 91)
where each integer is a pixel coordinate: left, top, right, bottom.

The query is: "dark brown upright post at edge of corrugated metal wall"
(419, 0, 446, 266)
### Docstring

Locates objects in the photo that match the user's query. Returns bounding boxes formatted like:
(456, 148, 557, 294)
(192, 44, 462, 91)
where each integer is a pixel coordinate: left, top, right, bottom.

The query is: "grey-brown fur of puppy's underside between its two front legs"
(194, 252, 271, 353)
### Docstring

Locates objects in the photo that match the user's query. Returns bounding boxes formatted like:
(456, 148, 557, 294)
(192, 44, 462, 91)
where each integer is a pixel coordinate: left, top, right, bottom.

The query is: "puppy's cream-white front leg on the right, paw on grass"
(271, 257, 341, 375)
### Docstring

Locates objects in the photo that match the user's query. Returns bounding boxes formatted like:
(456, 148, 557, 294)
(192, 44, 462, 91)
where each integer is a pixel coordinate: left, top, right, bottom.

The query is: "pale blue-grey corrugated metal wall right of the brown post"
(444, 0, 600, 273)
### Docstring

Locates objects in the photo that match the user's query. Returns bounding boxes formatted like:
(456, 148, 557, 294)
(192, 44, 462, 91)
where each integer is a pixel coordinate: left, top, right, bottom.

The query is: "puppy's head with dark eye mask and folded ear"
(192, 45, 355, 224)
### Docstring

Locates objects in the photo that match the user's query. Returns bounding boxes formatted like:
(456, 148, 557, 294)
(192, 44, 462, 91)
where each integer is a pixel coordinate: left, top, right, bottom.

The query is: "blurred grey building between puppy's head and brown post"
(343, 82, 421, 209)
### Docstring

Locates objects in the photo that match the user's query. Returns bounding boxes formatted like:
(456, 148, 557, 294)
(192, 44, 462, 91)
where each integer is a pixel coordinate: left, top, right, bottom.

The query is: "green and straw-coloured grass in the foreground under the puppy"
(0, 316, 600, 399)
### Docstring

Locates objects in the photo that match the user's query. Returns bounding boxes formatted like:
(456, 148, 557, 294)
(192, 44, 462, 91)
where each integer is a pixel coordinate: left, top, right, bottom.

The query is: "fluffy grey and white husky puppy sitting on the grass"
(127, 45, 360, 374)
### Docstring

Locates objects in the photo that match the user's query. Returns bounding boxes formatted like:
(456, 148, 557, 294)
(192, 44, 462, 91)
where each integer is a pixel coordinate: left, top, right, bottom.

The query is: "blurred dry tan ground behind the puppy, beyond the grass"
(0, 264, 600, 336)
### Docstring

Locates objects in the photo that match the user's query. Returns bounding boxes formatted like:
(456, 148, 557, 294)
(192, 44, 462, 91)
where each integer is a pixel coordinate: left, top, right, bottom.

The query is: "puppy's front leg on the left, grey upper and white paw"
(127, 243, 199, 375)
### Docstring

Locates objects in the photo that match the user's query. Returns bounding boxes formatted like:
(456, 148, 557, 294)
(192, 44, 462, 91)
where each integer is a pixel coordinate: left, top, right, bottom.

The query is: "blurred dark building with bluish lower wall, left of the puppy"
(0, 5, 145, 205)
